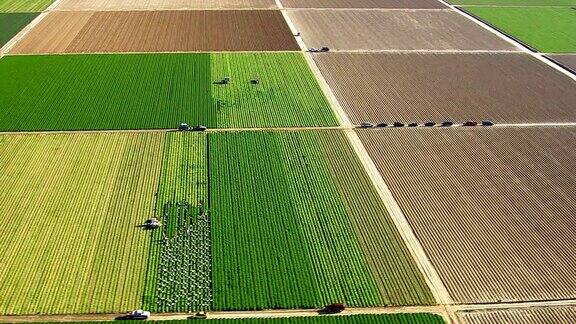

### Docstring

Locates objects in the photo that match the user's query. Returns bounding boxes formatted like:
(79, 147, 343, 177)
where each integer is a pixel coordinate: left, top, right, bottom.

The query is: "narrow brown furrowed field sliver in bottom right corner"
(457, 306, 576, 324)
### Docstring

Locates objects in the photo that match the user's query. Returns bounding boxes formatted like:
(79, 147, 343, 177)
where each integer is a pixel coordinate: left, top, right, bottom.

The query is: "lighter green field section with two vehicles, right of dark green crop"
(211, 53, 338, 128)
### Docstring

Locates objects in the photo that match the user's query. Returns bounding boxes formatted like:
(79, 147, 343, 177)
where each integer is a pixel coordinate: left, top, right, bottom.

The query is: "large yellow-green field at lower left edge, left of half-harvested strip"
(0, 134, 163, 314)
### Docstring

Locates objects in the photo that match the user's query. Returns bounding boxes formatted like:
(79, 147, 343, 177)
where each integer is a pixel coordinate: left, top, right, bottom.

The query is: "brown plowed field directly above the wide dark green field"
(12, 10, 299, 53)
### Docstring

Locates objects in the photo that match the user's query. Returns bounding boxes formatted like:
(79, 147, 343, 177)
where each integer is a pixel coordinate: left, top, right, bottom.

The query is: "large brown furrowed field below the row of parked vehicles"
(358, 127, 576, 303)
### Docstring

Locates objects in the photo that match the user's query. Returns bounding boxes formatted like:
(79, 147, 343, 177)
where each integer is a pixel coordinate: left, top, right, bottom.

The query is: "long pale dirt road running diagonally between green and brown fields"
(276, 0, 452, 305)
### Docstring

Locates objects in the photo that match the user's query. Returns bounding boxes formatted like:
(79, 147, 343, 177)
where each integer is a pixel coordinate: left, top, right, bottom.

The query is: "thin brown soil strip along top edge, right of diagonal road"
(282, 0, 447, 9)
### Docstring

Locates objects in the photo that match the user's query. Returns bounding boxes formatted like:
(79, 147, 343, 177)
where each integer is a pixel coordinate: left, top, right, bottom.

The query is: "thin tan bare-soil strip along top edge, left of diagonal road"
(56, 0, 277, 11)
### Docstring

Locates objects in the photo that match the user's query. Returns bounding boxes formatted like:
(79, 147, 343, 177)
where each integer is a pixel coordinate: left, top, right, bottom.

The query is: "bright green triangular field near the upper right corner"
(466, 7, 576, 53)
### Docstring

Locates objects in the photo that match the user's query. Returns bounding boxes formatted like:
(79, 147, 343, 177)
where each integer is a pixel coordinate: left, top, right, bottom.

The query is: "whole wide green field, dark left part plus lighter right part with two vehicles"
(0, 53, 337, 131)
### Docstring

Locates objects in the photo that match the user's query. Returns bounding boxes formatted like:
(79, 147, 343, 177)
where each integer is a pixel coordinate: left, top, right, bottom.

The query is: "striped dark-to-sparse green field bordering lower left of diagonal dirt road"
(208, 131, 433, 309)
